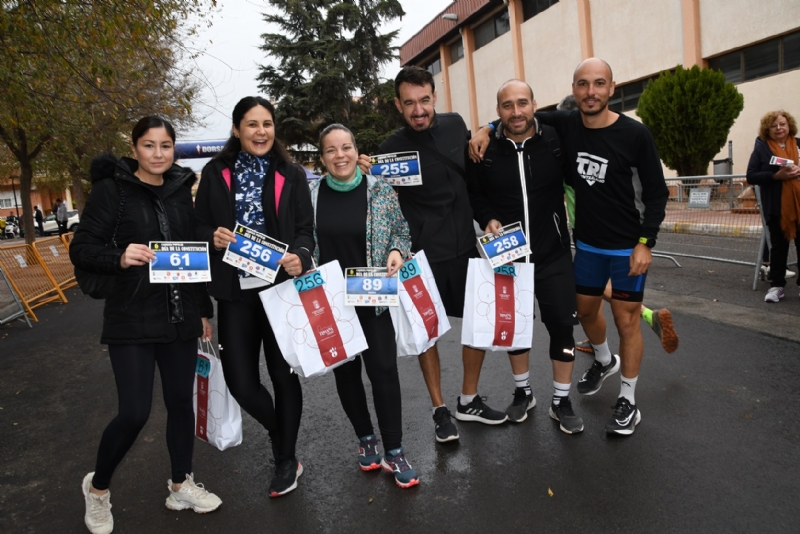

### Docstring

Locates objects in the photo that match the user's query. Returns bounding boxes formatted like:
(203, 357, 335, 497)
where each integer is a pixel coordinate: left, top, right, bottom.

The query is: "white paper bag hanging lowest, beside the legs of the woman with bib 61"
(194, 341, 242, 451)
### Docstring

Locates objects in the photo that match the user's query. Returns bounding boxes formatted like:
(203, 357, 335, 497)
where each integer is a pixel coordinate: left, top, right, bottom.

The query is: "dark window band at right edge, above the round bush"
(708, 32, 800, 83)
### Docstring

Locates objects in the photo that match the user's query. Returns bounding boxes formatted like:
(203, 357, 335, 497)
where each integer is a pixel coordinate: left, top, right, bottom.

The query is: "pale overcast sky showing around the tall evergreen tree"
(178, 0, 452, 170)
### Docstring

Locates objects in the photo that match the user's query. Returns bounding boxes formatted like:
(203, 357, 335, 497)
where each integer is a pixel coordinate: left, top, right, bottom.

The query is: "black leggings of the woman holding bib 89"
(333, 307, 403, 451)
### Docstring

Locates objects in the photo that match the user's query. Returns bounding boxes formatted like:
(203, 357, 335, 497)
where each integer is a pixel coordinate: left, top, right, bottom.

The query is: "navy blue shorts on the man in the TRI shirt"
(574, 241, 647, 302)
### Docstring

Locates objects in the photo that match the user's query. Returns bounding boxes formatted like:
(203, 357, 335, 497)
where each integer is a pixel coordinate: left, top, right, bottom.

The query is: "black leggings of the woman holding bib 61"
(92, 339, 197, 490)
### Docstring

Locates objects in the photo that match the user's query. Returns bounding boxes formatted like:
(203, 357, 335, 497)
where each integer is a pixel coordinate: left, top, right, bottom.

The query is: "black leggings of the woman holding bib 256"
(217, 288, 303, 463)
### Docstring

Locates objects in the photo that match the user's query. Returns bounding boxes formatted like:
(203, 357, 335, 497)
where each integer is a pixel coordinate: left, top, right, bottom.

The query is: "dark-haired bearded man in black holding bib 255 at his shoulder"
(379, 67, 506, 442)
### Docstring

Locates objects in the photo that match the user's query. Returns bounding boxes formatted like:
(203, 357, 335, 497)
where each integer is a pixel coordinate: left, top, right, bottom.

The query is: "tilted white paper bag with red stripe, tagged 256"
(259, 261, 367, 377)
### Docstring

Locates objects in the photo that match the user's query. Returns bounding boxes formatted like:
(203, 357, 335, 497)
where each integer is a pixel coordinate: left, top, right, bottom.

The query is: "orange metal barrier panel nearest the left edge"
(0, 245, 67, 321)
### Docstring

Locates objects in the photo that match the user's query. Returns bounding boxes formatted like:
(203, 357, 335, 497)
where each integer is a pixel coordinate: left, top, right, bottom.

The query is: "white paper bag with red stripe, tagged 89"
(389, 250, 450, 356)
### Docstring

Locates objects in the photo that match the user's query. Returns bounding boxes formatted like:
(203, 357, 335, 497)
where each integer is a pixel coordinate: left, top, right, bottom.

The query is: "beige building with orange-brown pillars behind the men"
(400, 0, 800, 175)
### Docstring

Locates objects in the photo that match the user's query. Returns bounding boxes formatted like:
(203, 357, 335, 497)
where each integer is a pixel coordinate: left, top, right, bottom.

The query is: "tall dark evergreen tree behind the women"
(258, 0, 405, 160)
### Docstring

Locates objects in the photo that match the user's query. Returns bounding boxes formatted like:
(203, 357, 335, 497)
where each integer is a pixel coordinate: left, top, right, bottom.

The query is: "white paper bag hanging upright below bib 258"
(461, 259, 533, 351)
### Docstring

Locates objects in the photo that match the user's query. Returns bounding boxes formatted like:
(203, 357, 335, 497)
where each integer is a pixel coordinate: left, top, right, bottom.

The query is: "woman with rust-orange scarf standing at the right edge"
(747, 109, 800, 302)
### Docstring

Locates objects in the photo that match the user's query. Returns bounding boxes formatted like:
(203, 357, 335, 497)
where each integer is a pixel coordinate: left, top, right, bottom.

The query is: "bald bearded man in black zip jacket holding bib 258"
(467, 80, 583, 434)
